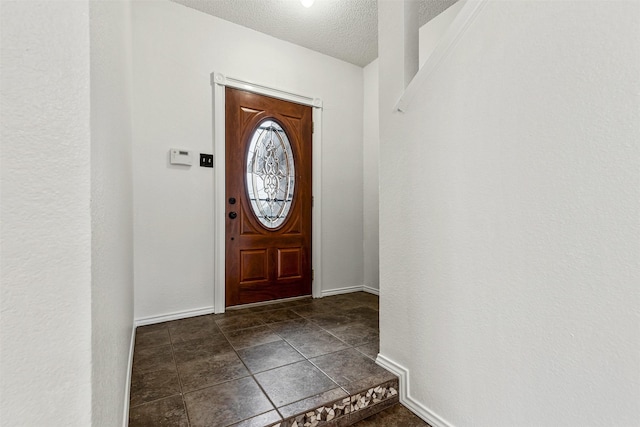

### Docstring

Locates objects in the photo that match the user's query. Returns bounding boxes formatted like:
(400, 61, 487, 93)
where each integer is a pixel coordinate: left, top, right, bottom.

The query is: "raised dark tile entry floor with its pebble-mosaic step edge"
(129, 292, 410, 427)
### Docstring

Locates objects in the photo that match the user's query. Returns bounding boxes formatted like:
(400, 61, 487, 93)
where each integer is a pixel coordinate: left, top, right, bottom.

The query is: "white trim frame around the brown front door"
(211, 72, 322, 314)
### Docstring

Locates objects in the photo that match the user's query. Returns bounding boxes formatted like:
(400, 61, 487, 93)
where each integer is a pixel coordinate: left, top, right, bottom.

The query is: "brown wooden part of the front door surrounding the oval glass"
(225, 87, 312, 307)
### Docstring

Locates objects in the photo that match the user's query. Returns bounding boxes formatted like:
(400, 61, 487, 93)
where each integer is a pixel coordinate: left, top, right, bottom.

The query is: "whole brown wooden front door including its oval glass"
(225, 87, 312, 307)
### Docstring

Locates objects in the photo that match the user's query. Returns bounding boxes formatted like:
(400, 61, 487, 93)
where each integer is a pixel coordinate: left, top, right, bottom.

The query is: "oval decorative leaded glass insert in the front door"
(245, 120, 295, 228)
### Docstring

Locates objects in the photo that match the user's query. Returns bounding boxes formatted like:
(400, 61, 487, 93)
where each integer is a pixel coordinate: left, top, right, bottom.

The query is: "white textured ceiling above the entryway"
(171, 0, 457, 66)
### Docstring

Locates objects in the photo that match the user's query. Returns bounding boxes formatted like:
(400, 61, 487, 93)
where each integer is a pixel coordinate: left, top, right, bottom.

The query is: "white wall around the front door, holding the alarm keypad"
(133, 1, 363, 318)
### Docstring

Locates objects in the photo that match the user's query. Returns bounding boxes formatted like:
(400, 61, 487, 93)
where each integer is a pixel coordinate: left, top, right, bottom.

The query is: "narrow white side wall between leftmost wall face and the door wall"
(89, 1, 133, 426)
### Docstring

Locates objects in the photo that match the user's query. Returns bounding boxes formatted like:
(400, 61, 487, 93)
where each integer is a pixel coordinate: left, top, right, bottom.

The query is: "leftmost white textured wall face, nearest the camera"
(0, 1, 91, 426)
